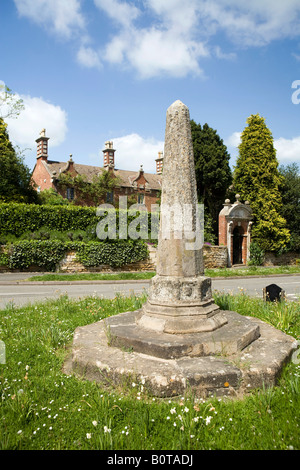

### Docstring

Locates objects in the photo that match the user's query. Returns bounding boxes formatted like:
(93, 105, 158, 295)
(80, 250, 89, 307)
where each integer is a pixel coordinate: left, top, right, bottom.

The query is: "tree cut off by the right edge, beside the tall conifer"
(279, 163, 300, 251)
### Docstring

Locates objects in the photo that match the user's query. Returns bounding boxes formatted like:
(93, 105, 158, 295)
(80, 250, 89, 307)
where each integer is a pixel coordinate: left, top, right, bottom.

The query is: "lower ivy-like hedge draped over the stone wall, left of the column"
(0, 240, 148, 271)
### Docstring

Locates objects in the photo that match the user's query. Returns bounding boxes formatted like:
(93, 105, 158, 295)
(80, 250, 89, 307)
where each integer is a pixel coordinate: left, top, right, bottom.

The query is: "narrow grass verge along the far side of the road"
(26, 266, 300, 282)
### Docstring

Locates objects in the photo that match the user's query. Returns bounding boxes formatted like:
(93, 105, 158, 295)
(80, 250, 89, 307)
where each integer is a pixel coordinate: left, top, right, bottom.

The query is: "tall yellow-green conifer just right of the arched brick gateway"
(234, 114, 290, 252)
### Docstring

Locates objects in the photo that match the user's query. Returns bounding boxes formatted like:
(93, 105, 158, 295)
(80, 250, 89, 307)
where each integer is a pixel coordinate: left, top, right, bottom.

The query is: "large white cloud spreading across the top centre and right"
(94, 0, 300, 78)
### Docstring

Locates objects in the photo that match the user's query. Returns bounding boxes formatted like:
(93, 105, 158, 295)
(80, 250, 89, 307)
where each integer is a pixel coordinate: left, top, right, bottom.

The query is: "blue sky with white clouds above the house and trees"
(0, 0, 300, 172)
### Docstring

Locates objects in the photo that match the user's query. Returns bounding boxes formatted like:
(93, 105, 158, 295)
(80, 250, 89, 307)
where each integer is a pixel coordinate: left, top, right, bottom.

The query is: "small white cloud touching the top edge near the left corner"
(14, 0, 85, 38)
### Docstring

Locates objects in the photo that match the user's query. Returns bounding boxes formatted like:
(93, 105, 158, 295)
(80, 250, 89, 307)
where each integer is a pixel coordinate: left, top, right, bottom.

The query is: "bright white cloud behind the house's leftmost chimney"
(6, 95, 67, 148)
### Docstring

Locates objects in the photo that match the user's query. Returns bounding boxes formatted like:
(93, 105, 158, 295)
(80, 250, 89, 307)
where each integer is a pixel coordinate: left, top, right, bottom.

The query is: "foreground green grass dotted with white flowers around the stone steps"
(0, 294, 300, 450)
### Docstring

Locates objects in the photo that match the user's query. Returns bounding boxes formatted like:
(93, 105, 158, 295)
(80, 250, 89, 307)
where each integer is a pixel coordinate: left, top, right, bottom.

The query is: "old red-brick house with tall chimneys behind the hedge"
(32, 129, 163, 211)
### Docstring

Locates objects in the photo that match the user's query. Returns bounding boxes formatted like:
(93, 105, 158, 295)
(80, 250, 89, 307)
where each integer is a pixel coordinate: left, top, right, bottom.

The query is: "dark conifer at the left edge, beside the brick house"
(0, 118, 38, 203)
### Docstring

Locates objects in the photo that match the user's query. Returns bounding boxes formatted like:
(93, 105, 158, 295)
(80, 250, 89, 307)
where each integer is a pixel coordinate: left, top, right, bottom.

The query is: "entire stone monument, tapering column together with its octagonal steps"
(65, 101, 297, 396)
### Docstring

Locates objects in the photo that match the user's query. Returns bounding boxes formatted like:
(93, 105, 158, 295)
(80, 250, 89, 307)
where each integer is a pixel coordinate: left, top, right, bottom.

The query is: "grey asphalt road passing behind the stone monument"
(0, 273, 300, 308)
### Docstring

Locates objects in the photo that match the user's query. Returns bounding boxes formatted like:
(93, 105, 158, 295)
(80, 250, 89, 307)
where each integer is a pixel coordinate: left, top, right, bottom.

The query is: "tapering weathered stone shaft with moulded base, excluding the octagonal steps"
(137, 101, 227, 334)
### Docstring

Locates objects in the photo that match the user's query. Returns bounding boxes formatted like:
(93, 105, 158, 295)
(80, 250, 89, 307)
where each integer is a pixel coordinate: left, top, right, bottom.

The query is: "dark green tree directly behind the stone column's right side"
(191, 120, 232, 236)
